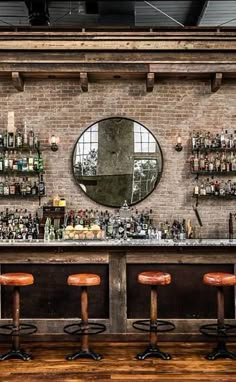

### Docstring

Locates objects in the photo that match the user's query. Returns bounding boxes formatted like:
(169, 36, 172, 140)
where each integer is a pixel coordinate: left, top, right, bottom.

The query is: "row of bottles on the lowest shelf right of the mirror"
(193, 178, 236, 197)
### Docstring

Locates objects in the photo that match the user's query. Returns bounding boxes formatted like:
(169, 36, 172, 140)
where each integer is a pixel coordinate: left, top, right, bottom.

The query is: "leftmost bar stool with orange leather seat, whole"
(0, 273, 37, 361)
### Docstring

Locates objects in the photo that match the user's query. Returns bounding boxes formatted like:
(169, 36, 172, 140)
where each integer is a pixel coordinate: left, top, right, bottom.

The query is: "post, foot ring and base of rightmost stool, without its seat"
(200, 286, 236, 361)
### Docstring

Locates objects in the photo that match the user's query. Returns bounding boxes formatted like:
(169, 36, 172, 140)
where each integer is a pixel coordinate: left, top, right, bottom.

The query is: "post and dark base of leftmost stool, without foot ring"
(0, 286, 32, 361)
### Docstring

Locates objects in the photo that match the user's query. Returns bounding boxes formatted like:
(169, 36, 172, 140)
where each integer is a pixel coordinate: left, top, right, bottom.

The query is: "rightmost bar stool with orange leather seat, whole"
(200, 272, 236, 360)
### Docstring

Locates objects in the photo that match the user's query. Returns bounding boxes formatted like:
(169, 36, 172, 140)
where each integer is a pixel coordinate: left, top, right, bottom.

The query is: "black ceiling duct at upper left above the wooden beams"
(25, 0, 50, 26)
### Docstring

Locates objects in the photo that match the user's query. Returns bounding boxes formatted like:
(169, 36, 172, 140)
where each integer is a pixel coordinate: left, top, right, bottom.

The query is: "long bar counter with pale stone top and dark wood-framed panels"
(0, 239, 236, 340)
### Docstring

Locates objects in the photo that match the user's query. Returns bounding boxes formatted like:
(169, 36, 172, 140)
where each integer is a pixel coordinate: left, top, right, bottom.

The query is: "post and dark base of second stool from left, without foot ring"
(66, 286, 102, 361)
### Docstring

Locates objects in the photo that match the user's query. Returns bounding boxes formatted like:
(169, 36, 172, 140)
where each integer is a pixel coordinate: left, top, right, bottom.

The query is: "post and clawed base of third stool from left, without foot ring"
(136, 285, 171, 360)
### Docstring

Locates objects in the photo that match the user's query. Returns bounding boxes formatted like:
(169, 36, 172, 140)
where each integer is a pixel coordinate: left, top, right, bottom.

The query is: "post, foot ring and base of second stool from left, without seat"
(64, 286, 106, 361)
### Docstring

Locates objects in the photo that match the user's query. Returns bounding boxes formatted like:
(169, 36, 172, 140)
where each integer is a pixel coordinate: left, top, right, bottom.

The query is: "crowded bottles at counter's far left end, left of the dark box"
(0, 208, 39, 241)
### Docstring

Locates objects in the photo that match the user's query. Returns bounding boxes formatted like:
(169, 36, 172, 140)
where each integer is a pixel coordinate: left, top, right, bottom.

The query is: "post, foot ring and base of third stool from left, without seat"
(133, 285, 175, 360)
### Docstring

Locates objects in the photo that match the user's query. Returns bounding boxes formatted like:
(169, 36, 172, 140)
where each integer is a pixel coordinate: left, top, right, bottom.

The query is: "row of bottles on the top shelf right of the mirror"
(192, 129, 236, 150)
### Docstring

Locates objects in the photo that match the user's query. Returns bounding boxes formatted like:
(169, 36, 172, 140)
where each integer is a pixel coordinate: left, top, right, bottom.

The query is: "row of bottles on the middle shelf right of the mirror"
(190, 151, 236, 172)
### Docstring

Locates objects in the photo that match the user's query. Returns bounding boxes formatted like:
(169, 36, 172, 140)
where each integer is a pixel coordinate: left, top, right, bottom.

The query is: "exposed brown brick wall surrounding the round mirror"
(0, 79, 236, 237)
